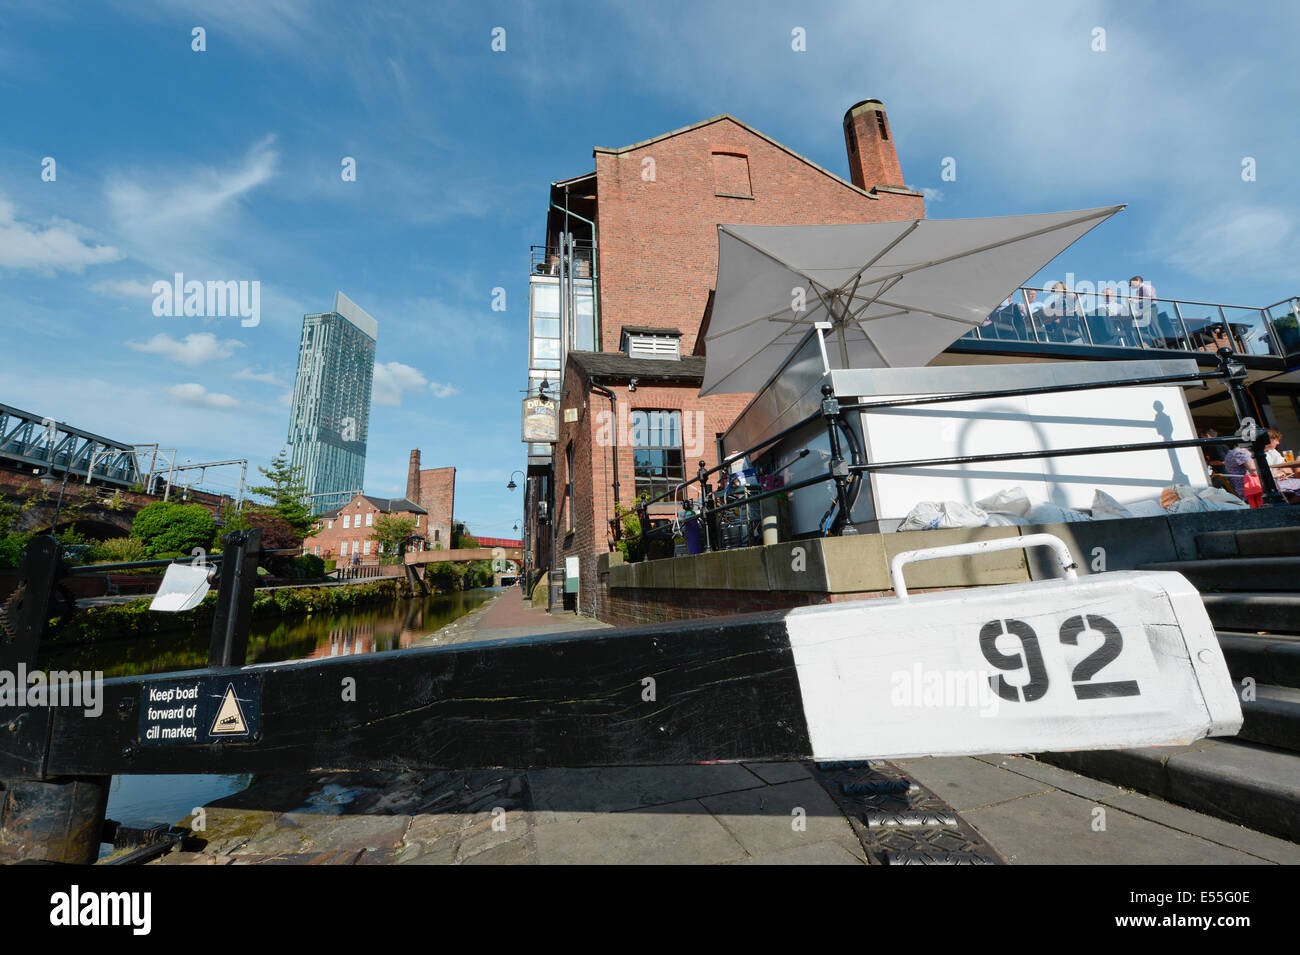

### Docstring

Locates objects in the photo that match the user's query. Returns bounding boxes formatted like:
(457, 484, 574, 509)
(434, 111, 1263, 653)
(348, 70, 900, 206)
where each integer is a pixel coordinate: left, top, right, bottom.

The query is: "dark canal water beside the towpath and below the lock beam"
(42, 589, 501, 851)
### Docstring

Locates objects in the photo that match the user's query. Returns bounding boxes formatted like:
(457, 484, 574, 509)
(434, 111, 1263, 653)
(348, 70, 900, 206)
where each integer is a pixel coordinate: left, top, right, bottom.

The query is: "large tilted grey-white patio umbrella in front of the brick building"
(699, 205, 1125, 395)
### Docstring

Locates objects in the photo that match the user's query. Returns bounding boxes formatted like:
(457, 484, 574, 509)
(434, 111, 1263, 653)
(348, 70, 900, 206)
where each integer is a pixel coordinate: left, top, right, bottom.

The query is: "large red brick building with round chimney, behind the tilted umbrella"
(525, 100, 926, 613)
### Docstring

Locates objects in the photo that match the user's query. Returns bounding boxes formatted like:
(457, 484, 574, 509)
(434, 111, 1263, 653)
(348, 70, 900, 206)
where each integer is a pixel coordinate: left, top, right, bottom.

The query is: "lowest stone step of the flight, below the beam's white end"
(1039, 738, 1300, 842)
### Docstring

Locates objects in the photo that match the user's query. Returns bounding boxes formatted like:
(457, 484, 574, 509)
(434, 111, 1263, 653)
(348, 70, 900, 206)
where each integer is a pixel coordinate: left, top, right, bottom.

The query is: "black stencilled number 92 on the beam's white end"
(979, 613, 1141, 703)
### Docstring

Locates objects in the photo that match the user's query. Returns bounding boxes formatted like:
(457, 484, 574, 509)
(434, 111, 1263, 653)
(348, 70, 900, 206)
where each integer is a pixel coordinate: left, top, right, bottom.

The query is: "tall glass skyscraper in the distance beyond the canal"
(289, 292, 380, 513)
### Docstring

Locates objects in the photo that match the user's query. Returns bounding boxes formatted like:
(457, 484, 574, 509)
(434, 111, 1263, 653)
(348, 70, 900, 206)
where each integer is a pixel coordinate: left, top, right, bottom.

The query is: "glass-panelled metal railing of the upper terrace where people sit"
(963, 287, 1300, 357)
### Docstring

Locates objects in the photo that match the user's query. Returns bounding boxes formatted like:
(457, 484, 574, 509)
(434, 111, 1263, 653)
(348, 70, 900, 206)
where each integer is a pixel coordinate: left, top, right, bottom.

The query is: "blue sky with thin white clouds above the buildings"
(0, 0, 1300, 535)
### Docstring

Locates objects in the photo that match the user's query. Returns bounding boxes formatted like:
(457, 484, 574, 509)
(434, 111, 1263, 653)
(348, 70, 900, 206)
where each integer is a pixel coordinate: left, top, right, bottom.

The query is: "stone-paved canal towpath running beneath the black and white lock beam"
(147, 590, 1300, 865)
